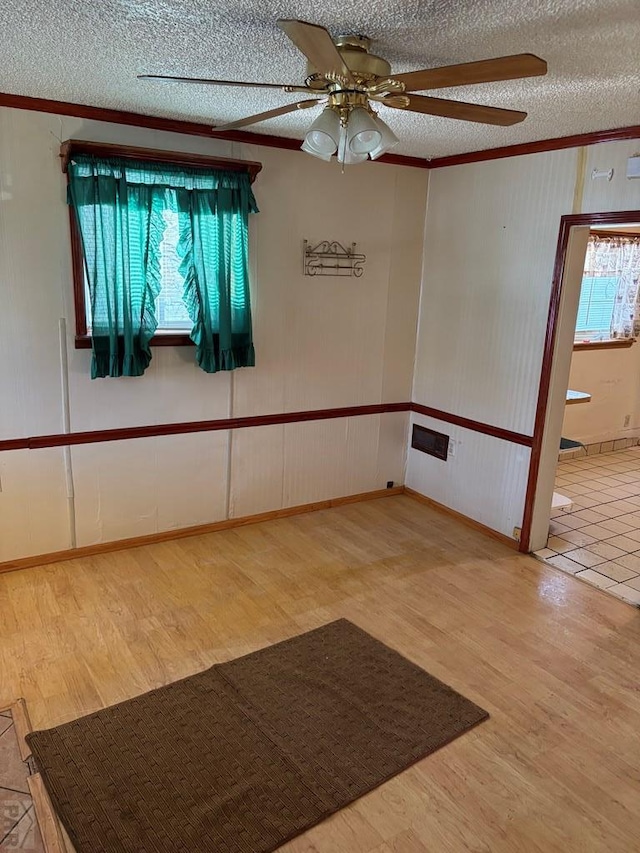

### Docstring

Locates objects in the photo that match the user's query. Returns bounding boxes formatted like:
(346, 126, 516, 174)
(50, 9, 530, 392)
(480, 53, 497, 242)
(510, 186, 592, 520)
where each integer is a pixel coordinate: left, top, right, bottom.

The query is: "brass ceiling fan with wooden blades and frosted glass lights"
(138, 19, 547, 164)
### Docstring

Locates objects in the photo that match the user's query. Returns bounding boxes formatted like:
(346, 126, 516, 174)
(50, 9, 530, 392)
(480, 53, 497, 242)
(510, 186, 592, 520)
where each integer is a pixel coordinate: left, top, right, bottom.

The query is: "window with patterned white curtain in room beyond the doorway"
(574, 231, 640, 343)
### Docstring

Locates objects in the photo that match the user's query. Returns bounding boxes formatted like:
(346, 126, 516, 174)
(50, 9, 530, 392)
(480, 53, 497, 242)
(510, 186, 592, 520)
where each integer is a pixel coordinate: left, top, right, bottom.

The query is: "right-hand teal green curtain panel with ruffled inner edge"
(177, 175, 257, 373)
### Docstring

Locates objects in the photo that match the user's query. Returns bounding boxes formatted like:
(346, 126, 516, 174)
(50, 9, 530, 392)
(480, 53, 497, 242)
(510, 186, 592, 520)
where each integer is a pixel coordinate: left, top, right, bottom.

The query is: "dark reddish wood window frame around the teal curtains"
(60, 139, 262, 349)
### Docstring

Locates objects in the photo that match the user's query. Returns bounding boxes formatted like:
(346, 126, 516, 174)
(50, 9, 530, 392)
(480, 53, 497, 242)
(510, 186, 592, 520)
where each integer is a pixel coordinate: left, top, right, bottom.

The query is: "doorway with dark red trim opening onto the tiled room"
(523, 211, 640, 606)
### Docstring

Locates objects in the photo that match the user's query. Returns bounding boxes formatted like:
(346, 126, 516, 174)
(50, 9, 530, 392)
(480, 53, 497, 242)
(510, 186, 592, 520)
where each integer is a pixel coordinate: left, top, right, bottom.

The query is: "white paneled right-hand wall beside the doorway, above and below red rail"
(407, 141, 640, 536)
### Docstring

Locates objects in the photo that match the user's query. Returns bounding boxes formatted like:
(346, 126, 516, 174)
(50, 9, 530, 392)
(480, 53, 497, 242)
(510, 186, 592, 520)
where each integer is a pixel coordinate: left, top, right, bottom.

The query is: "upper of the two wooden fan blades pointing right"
(392, 53, 547, 92)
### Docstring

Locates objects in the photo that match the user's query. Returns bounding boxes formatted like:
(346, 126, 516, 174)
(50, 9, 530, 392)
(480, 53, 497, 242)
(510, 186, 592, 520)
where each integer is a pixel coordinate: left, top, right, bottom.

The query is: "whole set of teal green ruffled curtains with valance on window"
(69, 155, 257, 378)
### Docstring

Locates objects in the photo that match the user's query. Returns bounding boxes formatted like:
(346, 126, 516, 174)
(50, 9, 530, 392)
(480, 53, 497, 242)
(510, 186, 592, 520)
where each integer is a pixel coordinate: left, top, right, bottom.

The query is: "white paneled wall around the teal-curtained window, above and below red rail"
(0, 108, 428, 561)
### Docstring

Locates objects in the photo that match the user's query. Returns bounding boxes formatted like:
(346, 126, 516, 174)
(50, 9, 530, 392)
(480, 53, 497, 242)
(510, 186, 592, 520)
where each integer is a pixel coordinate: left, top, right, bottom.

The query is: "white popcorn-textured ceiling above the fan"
(0, 0, 640, 157)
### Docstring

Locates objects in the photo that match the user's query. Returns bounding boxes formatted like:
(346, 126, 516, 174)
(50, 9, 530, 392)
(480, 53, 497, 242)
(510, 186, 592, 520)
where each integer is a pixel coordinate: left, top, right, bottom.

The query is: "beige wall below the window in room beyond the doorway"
(562, 344, 640, 444)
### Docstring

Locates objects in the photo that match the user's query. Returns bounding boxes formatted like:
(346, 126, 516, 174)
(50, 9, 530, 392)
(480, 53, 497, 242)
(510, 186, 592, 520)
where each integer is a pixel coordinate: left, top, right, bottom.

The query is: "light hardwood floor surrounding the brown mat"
(0, 496, 640, 853)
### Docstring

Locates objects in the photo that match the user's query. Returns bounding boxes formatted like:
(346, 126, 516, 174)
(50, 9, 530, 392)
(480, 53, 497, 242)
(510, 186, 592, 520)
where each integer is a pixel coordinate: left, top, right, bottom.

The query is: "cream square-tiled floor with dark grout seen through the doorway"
(535, 446, 640, 607)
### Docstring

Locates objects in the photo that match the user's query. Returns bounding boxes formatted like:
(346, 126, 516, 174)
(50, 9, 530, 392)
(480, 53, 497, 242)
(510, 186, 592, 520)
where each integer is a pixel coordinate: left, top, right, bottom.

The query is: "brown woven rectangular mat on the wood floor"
(28, 619, 488, 853)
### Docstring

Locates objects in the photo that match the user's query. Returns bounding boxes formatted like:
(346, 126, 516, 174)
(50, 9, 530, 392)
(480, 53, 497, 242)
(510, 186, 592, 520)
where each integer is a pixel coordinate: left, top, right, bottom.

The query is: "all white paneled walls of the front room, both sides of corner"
(0, 101, 640, 561)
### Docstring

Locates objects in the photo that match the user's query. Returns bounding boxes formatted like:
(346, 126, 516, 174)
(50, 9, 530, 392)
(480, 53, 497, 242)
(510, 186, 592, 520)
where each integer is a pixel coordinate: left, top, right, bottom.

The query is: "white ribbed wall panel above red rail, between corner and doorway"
(414, 150, 576, 434)
